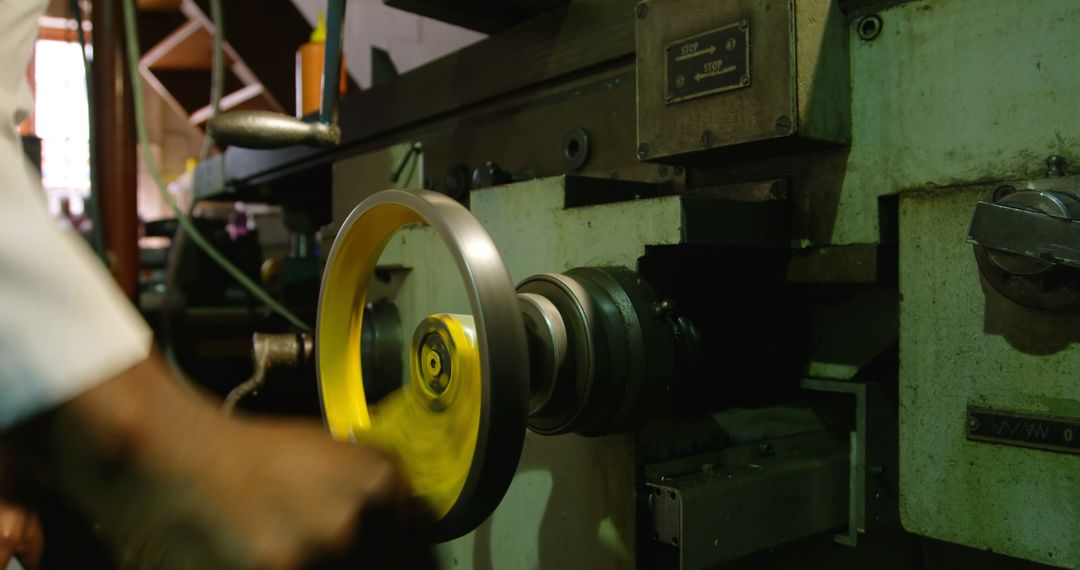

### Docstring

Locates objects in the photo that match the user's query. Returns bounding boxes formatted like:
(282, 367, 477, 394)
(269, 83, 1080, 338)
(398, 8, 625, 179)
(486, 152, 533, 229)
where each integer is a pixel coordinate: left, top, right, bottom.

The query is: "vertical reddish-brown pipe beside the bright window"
(92, 0, 138, 298)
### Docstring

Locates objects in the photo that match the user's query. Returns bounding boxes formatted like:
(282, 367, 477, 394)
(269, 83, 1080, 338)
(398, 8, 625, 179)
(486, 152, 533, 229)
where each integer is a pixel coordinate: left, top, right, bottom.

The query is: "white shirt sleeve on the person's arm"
(0, 0, 152, 430)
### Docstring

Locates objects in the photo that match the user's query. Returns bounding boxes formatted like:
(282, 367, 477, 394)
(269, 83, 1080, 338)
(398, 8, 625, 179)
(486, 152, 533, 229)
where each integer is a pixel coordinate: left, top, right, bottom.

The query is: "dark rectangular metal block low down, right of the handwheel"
(646, 432, 848, 570)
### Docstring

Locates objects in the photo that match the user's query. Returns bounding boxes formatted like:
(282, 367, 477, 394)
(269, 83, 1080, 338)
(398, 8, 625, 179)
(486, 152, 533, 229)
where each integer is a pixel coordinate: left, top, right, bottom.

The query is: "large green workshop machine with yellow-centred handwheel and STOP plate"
(183, 0, 1080, 570)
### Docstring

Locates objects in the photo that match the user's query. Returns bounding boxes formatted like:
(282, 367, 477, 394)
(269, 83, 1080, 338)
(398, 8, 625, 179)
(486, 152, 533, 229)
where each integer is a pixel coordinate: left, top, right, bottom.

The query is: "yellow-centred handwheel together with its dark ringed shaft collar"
(315, 190, 696, 540)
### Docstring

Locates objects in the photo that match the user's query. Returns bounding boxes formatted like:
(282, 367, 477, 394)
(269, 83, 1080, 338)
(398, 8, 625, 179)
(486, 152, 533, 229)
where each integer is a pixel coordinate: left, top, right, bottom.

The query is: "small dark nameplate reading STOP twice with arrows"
(664, 19, 750, 104)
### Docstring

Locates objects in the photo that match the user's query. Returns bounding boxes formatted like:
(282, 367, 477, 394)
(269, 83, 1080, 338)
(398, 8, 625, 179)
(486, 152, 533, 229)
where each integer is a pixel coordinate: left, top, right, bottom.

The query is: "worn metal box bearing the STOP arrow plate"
(635, 0, 851, 162)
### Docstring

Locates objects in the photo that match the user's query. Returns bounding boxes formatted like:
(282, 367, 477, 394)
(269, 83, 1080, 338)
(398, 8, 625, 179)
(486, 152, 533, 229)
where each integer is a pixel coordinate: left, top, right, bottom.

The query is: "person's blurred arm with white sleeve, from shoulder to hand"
(0, 0, 434, 569)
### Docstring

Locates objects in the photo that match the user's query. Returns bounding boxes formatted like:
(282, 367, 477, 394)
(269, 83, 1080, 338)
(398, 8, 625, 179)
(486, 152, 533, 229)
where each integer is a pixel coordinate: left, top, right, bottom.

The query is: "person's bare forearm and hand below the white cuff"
(11, 361, 430, 569)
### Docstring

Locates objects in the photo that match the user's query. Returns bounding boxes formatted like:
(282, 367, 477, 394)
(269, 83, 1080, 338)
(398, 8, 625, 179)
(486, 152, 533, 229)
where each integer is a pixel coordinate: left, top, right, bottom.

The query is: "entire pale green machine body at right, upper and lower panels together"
(859, 0, 1080, 567)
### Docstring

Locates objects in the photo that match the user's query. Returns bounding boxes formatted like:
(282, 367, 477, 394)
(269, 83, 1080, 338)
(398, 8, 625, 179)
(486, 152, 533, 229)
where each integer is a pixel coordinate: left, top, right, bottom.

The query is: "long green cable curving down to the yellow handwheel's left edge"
(123, 0, 311, 331)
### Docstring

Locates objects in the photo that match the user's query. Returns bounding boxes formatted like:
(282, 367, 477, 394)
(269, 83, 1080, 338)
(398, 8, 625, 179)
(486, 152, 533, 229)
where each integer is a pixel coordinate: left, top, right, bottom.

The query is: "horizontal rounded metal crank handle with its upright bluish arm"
(206, 0, 346, 149)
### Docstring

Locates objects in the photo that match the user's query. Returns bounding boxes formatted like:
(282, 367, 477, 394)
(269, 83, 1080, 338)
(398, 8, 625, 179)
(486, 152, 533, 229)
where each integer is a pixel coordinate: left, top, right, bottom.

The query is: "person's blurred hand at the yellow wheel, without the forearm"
(121, 420, 408, 568)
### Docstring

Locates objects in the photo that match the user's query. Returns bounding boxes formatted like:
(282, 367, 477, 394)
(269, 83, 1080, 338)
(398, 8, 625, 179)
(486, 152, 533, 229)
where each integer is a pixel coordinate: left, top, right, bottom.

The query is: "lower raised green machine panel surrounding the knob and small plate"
(900, 188, 1080, 567)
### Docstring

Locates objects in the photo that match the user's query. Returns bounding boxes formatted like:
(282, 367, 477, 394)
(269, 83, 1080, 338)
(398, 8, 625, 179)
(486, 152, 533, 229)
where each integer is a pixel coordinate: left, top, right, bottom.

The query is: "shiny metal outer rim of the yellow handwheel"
(315, 190, 528, 541)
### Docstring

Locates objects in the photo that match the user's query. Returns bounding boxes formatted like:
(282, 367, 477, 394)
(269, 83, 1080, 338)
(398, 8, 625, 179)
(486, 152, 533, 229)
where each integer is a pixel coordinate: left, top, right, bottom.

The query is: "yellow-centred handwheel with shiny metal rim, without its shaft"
(315, 190, 528, 540)
